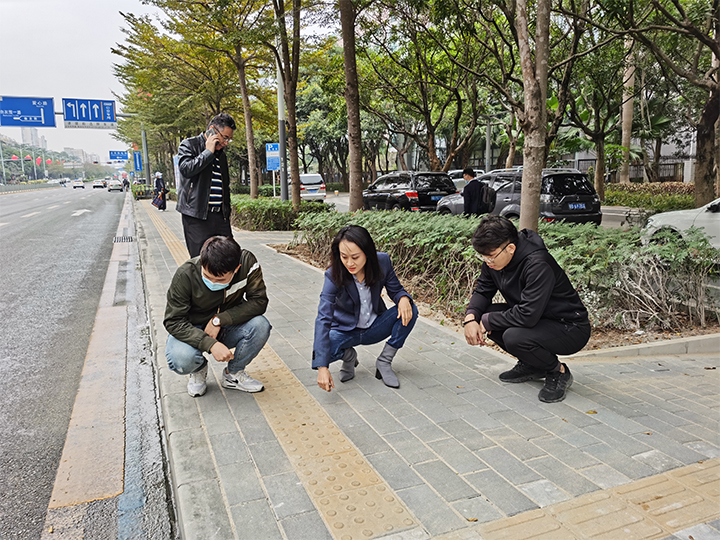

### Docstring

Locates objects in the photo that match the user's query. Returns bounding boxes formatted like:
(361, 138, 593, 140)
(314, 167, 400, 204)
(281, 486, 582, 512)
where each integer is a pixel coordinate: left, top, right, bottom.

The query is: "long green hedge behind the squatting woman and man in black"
(294, 211, 720, 328)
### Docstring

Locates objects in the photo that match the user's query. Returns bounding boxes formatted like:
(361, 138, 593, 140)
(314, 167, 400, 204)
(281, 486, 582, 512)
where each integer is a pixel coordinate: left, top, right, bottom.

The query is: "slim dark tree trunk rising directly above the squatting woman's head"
(338, 0, 363, 212)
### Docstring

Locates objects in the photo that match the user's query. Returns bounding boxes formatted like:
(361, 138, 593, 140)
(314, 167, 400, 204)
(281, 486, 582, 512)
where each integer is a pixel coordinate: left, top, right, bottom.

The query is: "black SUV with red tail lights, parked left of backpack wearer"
(363, 171, 457, 212)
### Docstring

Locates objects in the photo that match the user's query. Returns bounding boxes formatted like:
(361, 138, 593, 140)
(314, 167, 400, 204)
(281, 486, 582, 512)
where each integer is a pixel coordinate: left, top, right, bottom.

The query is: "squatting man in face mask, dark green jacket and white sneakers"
(163, 236, 271, 397)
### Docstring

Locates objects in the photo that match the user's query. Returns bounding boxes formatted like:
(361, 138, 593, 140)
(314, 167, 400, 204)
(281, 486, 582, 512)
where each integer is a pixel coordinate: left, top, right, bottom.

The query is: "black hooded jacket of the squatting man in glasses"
(466, 229, 588, 331)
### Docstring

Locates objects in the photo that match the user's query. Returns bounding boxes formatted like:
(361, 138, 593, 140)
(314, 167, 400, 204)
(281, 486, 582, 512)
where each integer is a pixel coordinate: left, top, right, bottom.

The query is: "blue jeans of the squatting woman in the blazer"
(329, 304, 418, 362)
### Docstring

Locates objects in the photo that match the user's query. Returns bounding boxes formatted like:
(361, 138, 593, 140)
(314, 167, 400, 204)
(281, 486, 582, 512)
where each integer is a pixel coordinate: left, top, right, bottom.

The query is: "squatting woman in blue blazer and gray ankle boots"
(312, 225, 418, 392)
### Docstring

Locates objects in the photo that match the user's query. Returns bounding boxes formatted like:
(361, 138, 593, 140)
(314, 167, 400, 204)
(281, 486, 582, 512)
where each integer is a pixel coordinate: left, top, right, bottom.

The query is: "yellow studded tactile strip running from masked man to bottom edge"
(250, 346, 416, 540)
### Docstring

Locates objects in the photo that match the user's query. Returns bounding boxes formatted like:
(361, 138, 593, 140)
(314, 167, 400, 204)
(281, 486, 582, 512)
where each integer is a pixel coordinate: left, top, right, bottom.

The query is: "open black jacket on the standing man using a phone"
(176, 133, 230, 219)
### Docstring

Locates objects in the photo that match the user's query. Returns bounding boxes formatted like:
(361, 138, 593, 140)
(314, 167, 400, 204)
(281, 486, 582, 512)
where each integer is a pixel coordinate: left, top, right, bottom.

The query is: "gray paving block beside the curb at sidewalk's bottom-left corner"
(177, 478, 233, 540)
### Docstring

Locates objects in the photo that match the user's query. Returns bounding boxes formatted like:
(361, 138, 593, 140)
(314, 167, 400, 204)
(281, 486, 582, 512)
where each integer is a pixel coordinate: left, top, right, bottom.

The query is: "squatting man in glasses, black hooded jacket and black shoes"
(463, 216, 590, 403)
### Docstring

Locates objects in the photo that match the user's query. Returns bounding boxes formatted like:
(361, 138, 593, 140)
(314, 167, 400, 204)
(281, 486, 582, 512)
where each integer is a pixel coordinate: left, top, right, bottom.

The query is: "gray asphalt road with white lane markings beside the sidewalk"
(0, 185, 125, 540)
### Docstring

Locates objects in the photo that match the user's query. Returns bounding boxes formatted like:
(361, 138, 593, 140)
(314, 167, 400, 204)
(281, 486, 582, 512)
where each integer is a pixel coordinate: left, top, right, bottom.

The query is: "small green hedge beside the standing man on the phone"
(231, 195, 335, 231)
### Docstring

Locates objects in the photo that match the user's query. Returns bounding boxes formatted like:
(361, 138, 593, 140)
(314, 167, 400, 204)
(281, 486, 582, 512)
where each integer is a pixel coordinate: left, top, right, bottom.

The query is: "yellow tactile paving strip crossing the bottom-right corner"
(438, 459, 720, 540)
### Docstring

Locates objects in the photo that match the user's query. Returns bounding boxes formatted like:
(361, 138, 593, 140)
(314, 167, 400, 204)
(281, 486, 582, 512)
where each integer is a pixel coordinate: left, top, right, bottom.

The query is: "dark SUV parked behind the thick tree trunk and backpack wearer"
(437, 168, 602, 225)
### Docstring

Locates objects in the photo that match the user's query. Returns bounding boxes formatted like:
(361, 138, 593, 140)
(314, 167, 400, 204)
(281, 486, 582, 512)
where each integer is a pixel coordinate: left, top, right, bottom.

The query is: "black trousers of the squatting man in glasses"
(488, 304, 590, 371)
